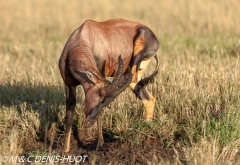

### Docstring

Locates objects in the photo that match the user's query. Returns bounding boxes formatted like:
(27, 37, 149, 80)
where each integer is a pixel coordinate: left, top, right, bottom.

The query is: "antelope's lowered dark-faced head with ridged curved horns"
(83, 56, 132, 128)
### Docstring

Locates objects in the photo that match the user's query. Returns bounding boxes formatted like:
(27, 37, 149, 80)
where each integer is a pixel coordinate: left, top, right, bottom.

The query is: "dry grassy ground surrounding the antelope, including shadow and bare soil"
(0, 0, 240, 165)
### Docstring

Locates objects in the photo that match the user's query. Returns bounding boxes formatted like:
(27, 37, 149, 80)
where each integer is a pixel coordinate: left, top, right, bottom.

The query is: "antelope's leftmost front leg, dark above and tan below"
(64, 86, 76, 152)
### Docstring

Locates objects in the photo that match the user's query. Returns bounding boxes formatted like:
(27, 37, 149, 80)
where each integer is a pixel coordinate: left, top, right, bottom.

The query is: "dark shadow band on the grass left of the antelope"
(0, 83, 65, 109)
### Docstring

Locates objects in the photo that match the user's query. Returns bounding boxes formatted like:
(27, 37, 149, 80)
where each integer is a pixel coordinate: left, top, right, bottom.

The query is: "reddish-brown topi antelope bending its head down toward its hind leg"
(59, 19, 159, 152)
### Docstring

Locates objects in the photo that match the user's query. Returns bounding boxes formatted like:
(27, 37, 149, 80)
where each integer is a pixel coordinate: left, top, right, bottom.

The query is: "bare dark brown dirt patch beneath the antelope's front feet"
(22, 130, 175, 164)
